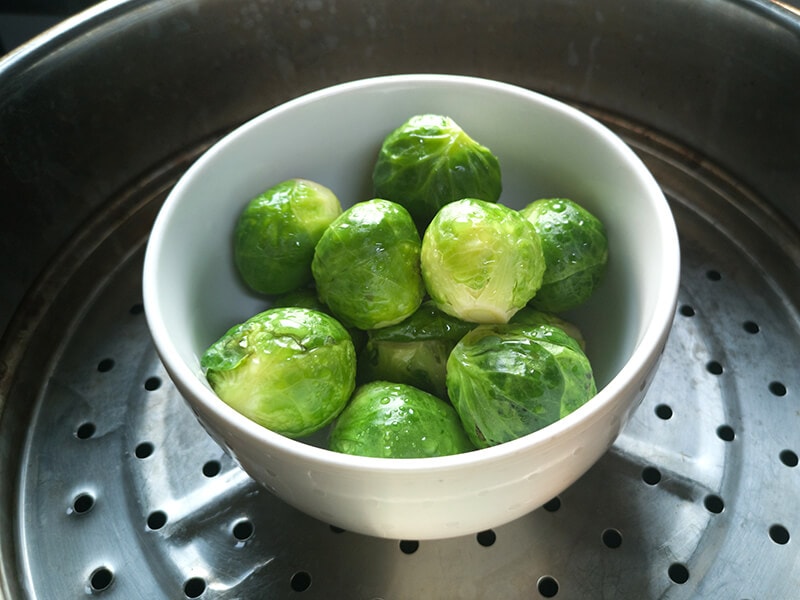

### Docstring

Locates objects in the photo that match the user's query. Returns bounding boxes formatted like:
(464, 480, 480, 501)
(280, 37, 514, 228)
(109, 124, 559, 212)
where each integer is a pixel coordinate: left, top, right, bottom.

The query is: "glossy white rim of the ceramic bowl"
(142, 73, 680, 474)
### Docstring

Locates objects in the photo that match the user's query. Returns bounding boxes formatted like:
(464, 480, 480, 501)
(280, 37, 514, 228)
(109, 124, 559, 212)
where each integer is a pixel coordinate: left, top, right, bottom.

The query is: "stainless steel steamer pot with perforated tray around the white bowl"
(0, 0, 800, 600)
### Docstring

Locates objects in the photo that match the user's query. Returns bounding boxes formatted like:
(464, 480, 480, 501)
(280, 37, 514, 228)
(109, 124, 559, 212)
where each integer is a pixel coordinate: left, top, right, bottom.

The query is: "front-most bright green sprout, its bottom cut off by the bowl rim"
(328, 381, 474, 458)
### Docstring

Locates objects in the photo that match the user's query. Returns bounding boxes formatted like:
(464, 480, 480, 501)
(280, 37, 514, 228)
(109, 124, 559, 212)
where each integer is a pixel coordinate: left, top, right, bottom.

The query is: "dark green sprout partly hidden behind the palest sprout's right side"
(520, 198, 608, 312)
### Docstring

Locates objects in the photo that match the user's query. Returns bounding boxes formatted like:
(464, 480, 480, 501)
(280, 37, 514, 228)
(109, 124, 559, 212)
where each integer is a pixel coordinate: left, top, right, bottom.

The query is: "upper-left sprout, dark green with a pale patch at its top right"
(233, 179, 342, 294)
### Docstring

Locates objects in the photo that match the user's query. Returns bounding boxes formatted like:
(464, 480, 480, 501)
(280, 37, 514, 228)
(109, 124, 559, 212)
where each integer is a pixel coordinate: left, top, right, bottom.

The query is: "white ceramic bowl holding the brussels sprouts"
(143, 75, 679, 539)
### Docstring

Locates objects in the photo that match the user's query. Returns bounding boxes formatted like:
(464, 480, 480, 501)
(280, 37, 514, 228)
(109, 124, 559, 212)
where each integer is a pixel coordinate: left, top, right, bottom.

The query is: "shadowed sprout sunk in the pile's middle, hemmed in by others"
(358, 300, 475, 398)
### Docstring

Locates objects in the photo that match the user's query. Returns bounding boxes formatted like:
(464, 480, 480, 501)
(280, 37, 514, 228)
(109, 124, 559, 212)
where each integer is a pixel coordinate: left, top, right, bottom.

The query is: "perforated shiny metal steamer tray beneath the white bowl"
(6, 115, 800, 600)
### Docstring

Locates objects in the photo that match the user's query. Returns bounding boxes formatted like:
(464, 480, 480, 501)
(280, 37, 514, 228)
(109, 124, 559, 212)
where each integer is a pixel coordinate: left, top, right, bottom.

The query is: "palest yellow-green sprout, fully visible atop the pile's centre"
(421, 198, 545, 323)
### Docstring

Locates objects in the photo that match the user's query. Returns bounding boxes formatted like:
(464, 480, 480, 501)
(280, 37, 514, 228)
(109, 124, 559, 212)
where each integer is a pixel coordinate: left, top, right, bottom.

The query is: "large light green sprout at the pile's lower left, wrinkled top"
(200, 308, 356, 438)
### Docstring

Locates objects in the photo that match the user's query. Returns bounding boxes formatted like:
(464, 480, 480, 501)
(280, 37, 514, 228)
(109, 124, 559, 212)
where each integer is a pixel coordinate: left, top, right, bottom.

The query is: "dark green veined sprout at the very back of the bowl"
(372, 114, 502, 231)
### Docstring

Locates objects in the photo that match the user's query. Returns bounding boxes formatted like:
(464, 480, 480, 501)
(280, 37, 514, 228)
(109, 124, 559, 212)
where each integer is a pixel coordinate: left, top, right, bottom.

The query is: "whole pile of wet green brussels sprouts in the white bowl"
(201, 114, 608, 458)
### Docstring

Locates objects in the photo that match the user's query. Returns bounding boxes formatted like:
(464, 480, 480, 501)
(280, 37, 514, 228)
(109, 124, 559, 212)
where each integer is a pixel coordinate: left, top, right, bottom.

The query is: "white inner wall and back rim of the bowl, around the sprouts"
(144, 75, 674, 448)
